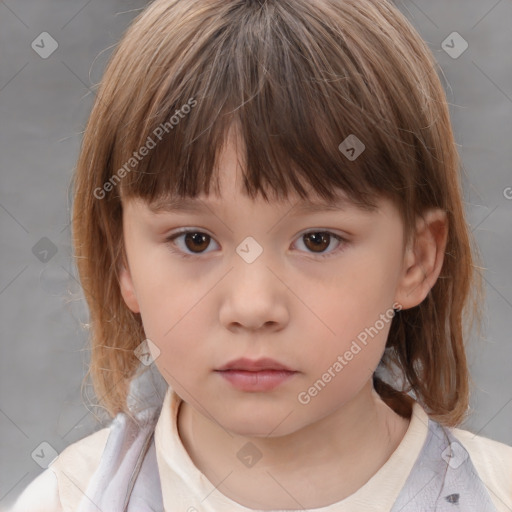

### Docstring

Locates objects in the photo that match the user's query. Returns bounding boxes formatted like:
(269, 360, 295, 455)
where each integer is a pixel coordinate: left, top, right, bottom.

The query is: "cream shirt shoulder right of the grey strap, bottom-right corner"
(451, 428, 512, 511)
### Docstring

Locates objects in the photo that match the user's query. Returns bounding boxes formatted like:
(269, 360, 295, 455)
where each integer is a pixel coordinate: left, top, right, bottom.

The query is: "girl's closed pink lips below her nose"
(215, 358, 298, 392)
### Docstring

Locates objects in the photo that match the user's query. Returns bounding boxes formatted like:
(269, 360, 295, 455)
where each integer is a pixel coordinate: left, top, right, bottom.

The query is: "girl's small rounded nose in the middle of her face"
(219, 251, 289, 331)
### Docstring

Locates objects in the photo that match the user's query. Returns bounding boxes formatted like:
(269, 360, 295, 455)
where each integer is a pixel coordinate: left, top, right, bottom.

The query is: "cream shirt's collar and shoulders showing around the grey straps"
(10, 388, 512, 512)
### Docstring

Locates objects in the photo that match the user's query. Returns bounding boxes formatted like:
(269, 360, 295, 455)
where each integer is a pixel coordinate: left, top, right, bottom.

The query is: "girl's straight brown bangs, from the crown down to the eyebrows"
(113, 0, 416, 214)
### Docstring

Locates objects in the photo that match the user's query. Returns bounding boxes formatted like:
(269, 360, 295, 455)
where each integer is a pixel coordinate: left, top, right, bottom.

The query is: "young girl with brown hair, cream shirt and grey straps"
(9, 0, 512, 512)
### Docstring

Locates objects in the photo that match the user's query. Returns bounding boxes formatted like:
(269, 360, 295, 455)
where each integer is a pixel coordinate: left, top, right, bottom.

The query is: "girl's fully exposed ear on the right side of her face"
(395, 208, 448, 309)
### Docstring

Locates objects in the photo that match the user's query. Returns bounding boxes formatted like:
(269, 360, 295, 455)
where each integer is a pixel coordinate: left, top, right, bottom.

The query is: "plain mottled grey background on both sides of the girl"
(0, 0, 512, 508)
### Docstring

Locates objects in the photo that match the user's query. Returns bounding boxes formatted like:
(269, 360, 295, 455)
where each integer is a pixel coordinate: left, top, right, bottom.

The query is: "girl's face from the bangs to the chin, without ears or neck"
(121, 132, 412, 436)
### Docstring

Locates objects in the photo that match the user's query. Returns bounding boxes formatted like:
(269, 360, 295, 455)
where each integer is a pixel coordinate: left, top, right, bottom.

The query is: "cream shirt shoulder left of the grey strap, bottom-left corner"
(9, 428, 110, 512)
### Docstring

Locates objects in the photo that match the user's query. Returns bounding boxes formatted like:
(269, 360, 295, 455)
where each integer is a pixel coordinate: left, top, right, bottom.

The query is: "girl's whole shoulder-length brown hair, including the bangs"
(73, 0, 482, 426)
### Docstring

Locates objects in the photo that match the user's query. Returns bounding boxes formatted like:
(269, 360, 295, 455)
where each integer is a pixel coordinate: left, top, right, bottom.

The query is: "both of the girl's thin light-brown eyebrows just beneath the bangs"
(149, 197, 372, 216)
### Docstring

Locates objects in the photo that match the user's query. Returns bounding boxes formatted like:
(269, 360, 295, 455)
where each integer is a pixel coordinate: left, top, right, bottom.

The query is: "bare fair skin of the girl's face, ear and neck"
(120, 131, 447, 510)
